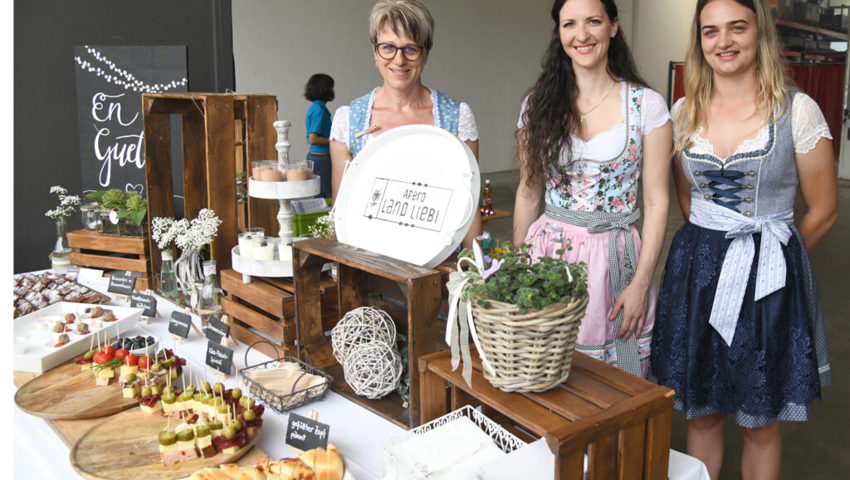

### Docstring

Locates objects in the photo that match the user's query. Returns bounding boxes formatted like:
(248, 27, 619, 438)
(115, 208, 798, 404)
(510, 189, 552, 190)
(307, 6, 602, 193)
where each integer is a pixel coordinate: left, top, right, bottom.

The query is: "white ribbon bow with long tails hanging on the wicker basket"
(446, 242, 501, 386)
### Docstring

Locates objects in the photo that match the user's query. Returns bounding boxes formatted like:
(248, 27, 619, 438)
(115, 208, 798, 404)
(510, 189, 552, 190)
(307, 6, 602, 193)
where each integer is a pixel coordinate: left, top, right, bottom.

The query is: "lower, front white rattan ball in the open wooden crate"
(342, 341, 402, 400)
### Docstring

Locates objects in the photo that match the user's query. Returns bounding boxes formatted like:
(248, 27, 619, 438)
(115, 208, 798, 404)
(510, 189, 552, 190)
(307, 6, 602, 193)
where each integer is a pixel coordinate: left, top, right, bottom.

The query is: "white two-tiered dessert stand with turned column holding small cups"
(231, 120, 321, 283)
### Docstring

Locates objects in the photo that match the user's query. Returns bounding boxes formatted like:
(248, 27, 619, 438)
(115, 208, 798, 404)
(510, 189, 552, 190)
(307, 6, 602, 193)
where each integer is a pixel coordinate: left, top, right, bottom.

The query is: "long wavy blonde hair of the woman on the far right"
(674, 0, 793, 154)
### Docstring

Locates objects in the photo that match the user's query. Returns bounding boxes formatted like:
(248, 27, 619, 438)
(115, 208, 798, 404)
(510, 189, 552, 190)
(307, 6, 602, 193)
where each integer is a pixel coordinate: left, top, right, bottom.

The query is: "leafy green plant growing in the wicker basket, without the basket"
(461, 244, 587, 313)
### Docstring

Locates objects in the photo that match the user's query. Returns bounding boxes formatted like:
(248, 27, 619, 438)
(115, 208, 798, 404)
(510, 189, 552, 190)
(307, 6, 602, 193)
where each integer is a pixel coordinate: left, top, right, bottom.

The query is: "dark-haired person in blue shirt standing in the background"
(304, 73, 334, 198)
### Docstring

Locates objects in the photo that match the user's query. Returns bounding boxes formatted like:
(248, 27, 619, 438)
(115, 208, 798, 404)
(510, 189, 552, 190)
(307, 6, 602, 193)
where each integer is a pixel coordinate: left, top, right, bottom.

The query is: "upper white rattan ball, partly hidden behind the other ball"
(331, 307, 396, 364)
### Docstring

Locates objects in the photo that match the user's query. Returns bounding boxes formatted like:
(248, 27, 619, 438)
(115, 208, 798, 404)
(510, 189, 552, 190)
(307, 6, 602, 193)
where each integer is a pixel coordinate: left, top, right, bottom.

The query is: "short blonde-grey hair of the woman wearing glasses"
(369, 0, 434, 51)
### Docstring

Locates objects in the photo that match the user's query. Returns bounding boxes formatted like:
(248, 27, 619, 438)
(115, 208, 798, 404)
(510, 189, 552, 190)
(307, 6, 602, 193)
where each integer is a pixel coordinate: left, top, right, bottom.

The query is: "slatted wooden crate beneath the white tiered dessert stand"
(221, 269, 339, 358)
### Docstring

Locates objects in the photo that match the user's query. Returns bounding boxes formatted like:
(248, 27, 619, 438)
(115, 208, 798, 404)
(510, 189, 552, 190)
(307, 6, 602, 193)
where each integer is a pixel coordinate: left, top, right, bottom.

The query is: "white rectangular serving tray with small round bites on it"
(13, 302, 143, 373)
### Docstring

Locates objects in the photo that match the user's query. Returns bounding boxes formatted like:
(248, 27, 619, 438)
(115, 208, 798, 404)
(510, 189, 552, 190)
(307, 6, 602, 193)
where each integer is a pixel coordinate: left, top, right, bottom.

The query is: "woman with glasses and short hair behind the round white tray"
(330, 0, 481, 248)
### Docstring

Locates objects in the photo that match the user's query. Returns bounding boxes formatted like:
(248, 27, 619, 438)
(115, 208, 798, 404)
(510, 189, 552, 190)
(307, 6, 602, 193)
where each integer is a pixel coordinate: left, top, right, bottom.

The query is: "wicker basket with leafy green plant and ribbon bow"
(446, 242, 587, 392)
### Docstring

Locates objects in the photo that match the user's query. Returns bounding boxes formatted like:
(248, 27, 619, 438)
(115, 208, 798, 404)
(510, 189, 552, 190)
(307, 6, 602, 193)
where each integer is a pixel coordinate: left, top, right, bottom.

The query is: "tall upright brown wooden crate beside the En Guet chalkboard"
(142, 92, 279, 292)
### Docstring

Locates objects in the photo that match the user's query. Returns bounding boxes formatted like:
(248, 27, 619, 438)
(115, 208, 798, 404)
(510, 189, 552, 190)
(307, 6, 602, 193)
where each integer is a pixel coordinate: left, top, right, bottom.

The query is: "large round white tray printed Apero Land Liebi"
(334, 125, 481, 268)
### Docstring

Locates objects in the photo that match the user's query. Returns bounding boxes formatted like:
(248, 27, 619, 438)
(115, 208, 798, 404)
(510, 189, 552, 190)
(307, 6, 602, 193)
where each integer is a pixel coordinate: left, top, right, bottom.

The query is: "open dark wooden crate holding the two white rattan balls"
(292, 239, 443, 428)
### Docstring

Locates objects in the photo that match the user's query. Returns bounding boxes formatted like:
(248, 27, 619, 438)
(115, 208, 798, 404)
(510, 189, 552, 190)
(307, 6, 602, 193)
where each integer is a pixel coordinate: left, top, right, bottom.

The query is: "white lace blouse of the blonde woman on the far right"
(670, 92, 832, 161)
